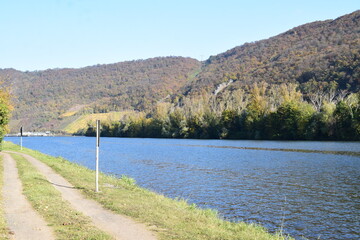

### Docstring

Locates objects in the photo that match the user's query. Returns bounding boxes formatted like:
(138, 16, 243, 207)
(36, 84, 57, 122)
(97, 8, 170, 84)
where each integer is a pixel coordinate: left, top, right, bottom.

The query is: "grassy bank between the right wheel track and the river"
(4, 142, 286, 240)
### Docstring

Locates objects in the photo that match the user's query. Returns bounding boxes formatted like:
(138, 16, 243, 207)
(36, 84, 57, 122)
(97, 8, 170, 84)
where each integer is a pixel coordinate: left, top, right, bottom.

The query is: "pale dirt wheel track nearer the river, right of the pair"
(8, 153, 156, 240)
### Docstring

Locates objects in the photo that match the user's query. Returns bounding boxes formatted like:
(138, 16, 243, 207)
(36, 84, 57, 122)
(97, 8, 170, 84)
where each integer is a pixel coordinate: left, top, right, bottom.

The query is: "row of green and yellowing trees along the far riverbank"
(77, 82, 360, 140)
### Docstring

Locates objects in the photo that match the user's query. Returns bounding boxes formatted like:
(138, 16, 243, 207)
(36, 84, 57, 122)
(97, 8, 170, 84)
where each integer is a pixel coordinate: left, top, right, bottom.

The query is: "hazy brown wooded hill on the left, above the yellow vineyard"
(0, 57, 200, 131)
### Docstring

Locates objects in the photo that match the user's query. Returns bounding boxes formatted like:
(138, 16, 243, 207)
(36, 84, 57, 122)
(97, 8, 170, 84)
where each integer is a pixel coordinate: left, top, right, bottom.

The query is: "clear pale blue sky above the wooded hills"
(0, 0, 360, 71)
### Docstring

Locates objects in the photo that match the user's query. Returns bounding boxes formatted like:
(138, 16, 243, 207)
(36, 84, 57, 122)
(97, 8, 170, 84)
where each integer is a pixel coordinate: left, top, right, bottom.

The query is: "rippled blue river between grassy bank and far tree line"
(5, 137, 360, 239)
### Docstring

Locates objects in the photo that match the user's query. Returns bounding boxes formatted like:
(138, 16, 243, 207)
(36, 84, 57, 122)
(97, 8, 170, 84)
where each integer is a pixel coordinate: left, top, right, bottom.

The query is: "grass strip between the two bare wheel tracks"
(11, 154, 112, 240)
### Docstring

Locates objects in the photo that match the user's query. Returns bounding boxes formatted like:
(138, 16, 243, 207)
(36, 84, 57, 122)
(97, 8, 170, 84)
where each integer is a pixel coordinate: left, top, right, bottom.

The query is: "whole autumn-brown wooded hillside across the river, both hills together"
(0, 11, 360, 131)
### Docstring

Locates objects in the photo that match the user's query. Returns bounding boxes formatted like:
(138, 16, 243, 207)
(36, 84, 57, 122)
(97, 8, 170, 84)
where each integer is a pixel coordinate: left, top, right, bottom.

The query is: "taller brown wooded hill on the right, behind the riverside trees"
(183, 11, 360, 93)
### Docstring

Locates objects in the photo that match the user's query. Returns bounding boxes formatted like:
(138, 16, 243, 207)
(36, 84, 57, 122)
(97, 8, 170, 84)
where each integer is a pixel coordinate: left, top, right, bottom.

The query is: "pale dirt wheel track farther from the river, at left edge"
(1, 153, 54, 240)
